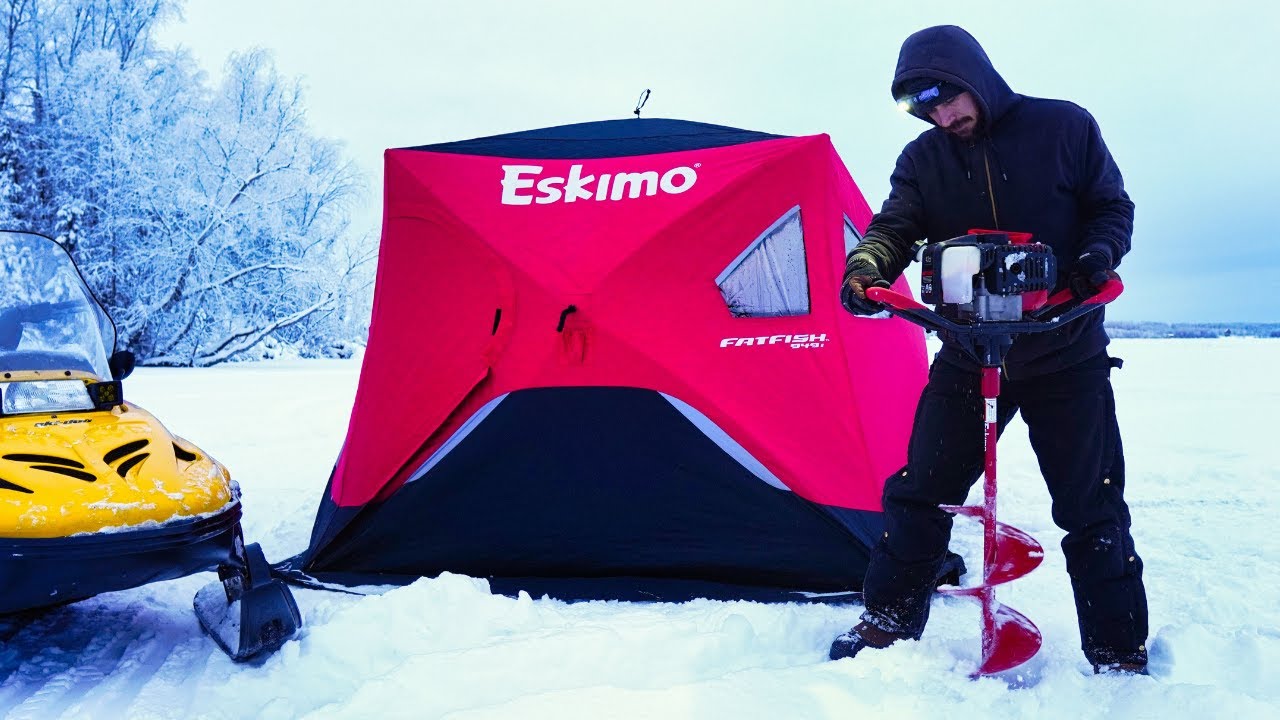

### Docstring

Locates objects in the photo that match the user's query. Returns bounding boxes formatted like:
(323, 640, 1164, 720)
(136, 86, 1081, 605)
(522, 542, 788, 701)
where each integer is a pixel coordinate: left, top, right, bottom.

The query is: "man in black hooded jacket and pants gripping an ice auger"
(831, 26, 1147, 673)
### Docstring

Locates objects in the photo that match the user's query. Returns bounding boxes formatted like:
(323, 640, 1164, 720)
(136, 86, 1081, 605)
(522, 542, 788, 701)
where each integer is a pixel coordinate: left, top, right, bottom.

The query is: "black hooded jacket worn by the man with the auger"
(849, 26, 1133, 377)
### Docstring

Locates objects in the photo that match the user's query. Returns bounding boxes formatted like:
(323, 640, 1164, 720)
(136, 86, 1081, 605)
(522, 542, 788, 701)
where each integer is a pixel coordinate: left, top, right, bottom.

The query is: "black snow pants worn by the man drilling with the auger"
(863, 352, 1147, 665)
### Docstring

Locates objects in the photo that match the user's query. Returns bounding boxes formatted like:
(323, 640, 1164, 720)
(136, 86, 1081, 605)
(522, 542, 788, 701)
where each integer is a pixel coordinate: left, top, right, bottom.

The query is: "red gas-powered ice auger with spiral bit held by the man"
(867, 231, 1124, 675)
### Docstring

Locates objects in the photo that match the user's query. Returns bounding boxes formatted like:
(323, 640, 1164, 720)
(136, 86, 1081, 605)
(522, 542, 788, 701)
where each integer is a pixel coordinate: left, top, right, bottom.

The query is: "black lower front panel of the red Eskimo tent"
(305, 387, 877, 600)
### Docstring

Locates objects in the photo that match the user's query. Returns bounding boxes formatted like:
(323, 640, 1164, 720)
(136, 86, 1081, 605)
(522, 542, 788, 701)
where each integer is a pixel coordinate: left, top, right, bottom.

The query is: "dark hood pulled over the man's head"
(890, 26, 1018, 127)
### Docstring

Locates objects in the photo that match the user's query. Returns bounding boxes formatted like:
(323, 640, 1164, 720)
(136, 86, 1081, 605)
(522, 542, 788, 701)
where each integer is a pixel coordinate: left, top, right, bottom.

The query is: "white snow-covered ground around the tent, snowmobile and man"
(0, 338, 1280, 720)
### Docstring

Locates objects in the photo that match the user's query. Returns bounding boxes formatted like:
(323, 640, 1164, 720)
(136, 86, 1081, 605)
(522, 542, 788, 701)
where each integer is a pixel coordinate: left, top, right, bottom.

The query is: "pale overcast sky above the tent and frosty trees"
(160, 0, 1280, 322)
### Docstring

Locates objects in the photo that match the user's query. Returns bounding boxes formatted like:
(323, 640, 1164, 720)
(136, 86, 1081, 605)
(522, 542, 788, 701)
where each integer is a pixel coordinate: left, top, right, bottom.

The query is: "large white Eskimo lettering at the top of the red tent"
(502, 163, 701, 205)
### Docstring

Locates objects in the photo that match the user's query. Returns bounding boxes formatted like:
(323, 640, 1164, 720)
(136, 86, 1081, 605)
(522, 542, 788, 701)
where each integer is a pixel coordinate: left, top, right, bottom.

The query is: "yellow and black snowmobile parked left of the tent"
(0, 232, 301, 661)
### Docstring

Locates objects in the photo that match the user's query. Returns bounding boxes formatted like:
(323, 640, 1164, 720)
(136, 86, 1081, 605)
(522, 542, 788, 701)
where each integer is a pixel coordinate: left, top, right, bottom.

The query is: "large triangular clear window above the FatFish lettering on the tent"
(716, 205, 809, 318)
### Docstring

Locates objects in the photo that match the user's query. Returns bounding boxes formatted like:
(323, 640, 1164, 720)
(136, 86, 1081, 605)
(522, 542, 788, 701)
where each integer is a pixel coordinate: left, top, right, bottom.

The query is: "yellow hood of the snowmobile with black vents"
(0, 392, 238, 538)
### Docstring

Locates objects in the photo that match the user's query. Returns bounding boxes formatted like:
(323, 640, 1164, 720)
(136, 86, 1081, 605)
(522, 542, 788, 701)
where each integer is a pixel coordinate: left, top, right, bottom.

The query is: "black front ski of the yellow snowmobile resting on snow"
(195, 534, 302, 662)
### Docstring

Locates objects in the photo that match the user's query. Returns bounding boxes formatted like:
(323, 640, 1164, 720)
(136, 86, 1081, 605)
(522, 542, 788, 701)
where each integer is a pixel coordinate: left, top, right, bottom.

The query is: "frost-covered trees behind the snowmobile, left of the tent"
(0, 0, 372, 365)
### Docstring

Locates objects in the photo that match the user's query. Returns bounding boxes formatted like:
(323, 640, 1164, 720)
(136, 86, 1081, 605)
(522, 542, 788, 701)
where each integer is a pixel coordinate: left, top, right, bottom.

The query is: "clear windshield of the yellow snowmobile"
(0, 232, 115, 379)
